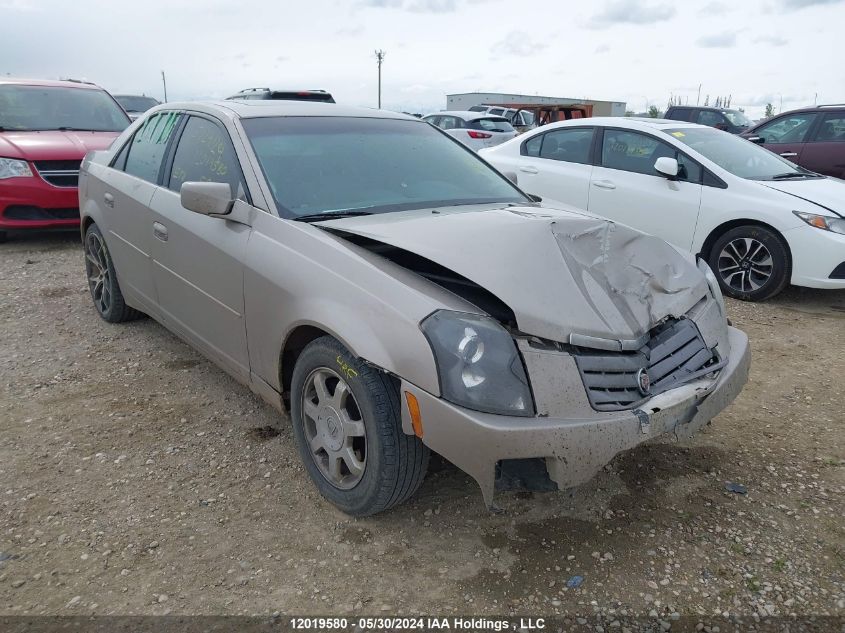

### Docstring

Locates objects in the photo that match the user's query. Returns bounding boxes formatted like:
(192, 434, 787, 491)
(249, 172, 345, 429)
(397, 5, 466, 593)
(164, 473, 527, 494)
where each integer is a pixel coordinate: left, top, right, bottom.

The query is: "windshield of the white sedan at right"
(666, 127, 815, 180)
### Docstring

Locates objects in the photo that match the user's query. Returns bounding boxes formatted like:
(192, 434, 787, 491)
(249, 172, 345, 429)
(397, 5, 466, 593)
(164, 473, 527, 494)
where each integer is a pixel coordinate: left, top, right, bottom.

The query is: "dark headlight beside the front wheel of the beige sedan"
(420, 310, 534, 416)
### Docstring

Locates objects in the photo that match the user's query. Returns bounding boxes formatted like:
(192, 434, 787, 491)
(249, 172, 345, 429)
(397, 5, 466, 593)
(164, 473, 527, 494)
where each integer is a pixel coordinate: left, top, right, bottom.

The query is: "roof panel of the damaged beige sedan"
(148, 99, 420, 121)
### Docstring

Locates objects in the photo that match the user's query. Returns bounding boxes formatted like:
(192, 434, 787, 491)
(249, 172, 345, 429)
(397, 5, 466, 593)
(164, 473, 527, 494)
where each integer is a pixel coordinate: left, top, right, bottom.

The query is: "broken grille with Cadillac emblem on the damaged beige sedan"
(575, 319, 724, 411)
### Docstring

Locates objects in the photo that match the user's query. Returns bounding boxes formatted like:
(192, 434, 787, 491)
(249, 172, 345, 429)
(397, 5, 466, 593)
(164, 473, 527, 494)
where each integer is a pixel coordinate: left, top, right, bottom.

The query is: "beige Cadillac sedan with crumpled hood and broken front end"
(80, 101, 750, 515)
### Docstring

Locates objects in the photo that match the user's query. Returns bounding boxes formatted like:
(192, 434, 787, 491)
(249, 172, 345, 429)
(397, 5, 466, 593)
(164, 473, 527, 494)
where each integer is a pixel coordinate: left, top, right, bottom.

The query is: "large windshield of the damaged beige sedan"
(243, 117, 530, 218)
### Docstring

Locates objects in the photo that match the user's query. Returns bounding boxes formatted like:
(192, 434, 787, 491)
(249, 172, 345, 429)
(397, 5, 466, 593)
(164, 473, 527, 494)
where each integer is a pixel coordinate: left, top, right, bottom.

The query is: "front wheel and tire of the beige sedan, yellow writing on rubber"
(291, 336, 429, 517)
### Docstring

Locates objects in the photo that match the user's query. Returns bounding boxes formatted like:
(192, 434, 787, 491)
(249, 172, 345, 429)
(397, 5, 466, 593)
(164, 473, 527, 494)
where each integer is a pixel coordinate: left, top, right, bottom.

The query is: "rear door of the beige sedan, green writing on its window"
(97, 112, 180, 314)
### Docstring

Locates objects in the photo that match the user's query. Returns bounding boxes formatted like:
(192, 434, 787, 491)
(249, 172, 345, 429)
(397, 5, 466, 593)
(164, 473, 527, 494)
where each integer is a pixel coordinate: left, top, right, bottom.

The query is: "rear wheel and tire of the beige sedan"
(82, 224, 143, 323)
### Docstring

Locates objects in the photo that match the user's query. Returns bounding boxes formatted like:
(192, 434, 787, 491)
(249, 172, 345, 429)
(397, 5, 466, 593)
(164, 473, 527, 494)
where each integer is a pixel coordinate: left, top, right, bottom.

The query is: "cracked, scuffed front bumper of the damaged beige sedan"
(402, 328, 751, 507)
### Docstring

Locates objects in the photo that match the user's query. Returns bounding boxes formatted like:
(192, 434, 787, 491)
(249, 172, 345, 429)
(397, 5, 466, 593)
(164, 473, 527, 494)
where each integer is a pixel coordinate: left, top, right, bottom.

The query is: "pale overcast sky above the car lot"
(0, 0, 845, 117)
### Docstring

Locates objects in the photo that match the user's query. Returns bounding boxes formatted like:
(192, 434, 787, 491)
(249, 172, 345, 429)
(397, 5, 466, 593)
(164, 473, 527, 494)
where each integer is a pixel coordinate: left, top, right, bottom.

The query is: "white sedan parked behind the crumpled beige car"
(481, 117, 845, 301)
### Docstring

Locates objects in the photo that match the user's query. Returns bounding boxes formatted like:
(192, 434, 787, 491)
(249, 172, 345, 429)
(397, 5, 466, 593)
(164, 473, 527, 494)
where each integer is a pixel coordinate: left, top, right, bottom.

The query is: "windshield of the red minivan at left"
(0, 84, 129, 132)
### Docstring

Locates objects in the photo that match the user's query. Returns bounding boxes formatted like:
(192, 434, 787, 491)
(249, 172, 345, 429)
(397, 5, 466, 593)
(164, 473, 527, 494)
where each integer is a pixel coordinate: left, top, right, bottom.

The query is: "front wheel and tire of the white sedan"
(708, 224, 792, 301)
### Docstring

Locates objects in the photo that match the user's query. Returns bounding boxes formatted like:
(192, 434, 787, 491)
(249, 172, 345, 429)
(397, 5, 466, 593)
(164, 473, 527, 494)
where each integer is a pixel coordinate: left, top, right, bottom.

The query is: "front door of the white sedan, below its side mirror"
(588, 128, 703, 250)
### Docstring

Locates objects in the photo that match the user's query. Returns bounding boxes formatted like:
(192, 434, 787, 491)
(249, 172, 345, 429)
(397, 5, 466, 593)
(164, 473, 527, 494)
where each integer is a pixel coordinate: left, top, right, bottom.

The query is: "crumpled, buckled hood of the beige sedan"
(317, 207, 708, 342)
